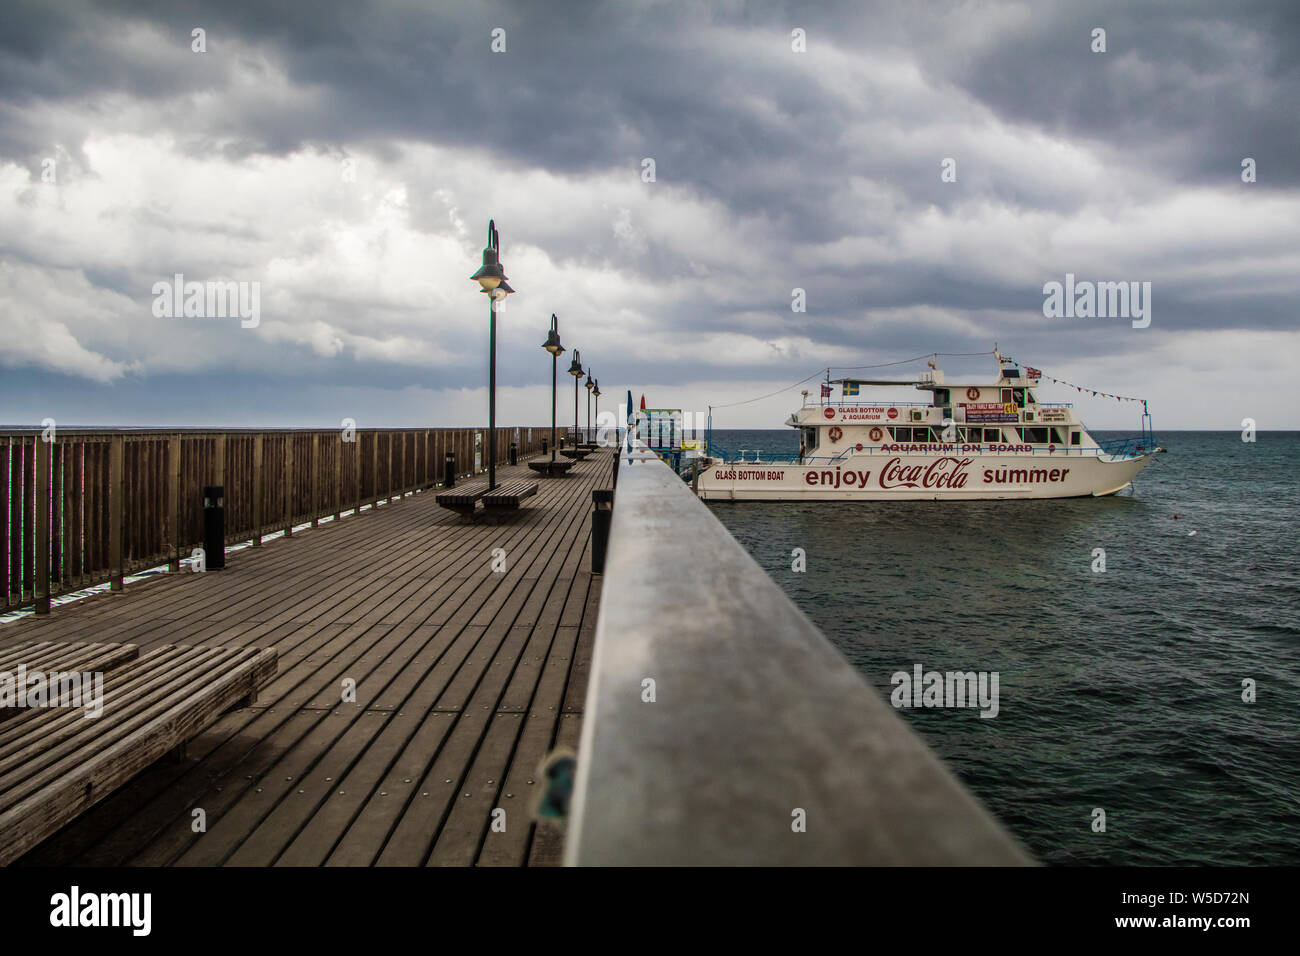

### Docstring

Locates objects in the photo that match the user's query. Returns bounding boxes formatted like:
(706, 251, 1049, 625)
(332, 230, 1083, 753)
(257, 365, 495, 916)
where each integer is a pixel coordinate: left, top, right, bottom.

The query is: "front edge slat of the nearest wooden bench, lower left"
(0, 648, 276, 865)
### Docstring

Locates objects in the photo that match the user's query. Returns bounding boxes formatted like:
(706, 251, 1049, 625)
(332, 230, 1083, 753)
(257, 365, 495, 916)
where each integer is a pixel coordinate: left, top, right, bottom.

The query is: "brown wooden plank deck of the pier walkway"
(0, 447, 611, 866)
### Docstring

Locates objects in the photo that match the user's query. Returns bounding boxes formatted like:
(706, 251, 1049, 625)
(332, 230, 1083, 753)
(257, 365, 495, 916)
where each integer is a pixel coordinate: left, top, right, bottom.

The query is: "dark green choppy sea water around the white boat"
(709, 429, 1300, 865)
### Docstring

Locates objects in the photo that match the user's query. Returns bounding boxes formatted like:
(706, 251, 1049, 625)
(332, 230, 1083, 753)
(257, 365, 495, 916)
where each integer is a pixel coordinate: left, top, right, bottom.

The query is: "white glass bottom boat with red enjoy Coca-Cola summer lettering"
(696, 356, 1164, 501)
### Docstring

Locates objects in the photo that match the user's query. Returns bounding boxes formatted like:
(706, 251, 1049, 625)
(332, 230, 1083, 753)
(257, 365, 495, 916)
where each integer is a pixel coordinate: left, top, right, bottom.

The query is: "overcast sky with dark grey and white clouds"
(0, 0, 1300, 429)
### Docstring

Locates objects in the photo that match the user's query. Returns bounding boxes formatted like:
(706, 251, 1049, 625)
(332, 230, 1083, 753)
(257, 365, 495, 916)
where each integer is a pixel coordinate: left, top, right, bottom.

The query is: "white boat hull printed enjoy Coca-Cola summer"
(697, 453, 1154, 501)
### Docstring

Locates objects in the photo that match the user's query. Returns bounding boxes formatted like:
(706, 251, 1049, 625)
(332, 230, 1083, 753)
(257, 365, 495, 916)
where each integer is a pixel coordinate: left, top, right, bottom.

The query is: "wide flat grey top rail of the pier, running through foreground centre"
(564, 451, 1031, 866)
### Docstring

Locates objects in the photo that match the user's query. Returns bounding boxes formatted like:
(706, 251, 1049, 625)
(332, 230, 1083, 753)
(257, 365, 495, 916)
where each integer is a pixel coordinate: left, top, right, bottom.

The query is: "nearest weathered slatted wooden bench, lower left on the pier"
(0, 644, 276, 865)
